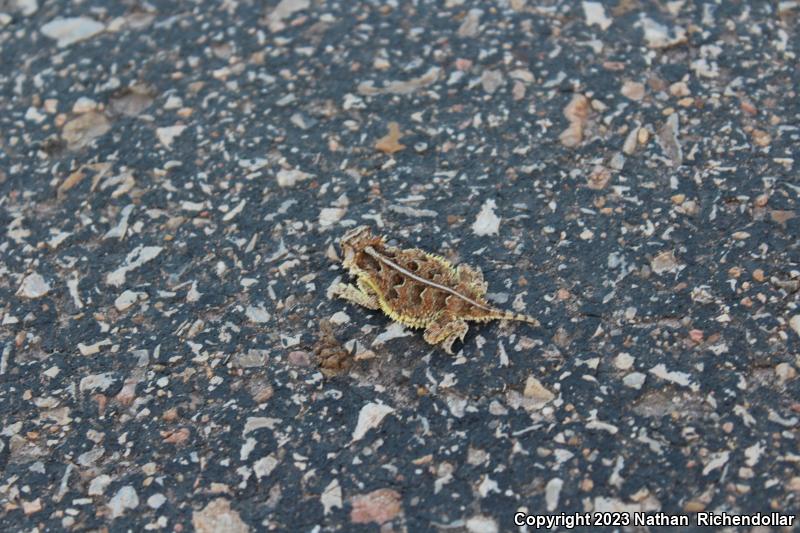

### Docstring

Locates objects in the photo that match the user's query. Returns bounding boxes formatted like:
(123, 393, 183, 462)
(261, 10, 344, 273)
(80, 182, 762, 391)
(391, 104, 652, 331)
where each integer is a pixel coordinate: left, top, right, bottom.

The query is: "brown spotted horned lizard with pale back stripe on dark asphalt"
(333, 226, 539, 354)
